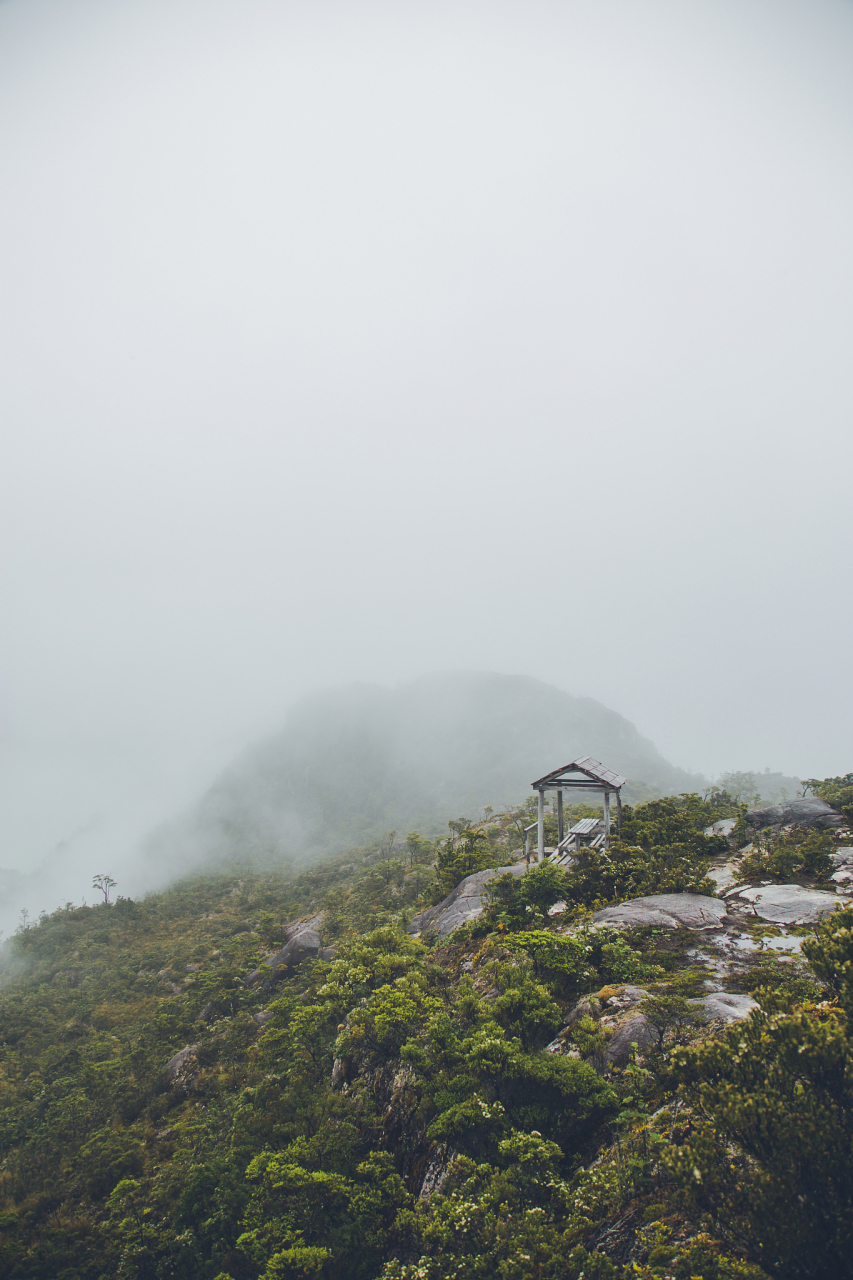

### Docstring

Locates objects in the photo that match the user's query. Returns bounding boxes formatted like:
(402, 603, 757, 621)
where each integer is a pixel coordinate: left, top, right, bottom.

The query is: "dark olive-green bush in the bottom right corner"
(667, 909, 853, 1280)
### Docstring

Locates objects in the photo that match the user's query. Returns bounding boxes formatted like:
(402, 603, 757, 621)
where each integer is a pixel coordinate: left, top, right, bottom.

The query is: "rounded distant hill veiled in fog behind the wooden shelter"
(149, 672, 704, 865)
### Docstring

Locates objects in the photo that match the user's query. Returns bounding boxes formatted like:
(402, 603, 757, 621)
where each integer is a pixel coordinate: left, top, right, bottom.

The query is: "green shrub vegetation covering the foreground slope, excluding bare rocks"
(0, 776, 853, 1280)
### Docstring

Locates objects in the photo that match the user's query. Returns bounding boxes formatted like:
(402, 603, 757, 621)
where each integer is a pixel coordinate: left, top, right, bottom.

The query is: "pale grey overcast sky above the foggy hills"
(0, 0, 853, 890)
